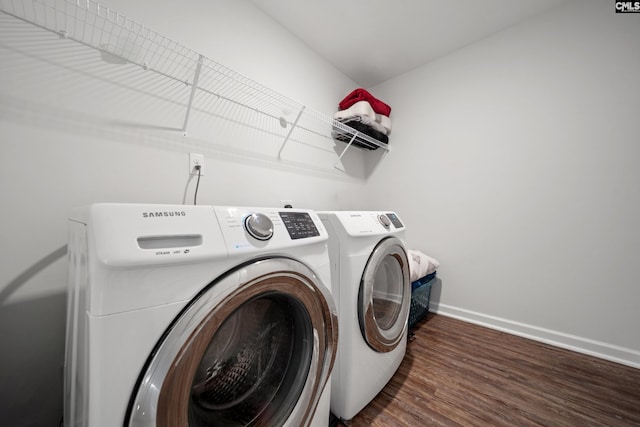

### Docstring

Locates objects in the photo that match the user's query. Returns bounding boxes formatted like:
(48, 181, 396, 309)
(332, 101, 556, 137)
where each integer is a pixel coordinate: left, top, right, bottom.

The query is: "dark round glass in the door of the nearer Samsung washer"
(189, 295, 313, 426)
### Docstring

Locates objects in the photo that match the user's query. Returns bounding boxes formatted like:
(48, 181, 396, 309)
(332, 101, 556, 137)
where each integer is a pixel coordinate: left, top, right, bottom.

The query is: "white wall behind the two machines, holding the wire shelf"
(0, 0, 365, 425)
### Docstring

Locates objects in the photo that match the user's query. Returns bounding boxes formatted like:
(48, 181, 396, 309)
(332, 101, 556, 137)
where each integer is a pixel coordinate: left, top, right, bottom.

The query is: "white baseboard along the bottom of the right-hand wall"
(429, 301, 640, 368)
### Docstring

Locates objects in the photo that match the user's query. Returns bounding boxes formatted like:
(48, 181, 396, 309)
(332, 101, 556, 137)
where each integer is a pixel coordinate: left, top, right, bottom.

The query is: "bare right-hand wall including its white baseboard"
(367, 0, 640, 366)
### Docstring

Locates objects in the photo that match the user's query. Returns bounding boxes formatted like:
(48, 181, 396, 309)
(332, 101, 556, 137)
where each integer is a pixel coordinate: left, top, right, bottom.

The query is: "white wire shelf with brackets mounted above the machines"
(0, 0, 389, 159)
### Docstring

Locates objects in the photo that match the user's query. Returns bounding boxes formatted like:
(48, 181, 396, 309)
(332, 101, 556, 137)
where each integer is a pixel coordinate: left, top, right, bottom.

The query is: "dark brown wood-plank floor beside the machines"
(339, 313, 640, 427)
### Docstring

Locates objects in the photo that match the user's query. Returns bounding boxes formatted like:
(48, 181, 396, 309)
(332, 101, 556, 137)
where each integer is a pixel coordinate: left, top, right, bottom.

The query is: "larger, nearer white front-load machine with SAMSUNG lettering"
(64, 204, 338, 427)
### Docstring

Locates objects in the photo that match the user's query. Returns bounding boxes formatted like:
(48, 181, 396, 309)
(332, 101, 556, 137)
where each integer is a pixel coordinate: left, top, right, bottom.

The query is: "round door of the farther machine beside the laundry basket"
(358, 237, 411, 353)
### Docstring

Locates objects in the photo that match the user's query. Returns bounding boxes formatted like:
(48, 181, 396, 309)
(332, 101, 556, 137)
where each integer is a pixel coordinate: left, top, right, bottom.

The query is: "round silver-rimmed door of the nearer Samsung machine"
(128, 258, 338, 427)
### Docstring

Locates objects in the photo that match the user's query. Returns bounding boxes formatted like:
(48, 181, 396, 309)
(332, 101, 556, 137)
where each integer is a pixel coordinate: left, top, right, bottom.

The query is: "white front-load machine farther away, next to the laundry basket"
(318, 211, 411, 420)
